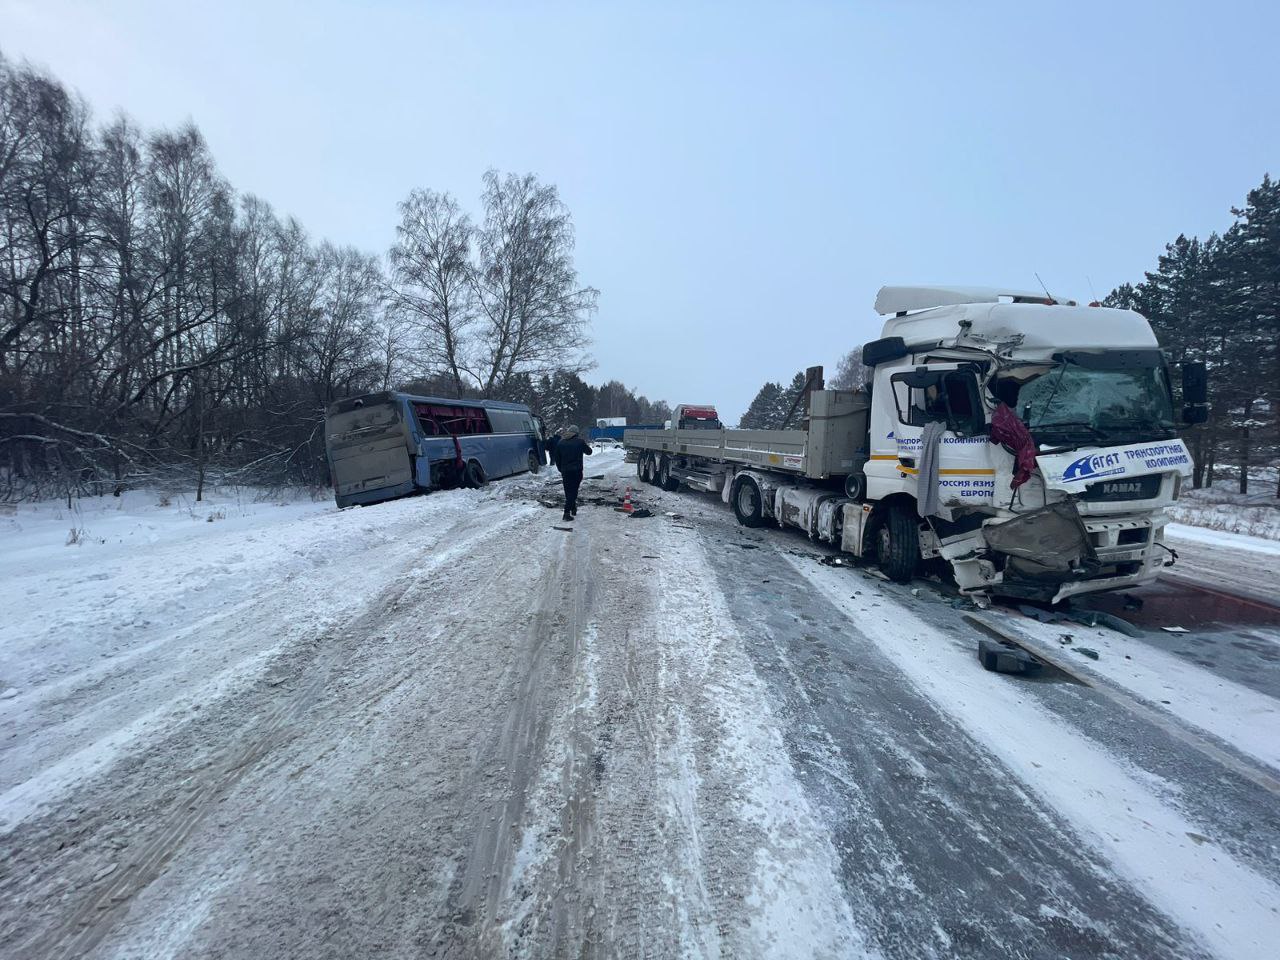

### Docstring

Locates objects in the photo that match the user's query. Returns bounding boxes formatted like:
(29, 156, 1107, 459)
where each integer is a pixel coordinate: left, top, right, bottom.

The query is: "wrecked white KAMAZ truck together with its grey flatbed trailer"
(625, 287, 1208, 602)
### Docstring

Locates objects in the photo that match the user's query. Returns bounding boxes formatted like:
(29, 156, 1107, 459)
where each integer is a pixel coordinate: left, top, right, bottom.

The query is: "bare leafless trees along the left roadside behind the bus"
(0, 54, 629, 499)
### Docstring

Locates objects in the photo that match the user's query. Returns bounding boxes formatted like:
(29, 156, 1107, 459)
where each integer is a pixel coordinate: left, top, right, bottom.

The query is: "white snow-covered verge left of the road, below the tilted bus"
(0, 483, 517, 831)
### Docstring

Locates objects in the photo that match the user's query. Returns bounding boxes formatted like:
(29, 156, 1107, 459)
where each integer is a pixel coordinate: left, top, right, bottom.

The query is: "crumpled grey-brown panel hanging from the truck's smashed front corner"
(982, 500, 1098, 586)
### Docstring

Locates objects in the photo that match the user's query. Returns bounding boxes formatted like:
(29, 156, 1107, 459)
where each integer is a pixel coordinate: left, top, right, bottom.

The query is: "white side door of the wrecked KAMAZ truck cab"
(890, 364, 996, 506)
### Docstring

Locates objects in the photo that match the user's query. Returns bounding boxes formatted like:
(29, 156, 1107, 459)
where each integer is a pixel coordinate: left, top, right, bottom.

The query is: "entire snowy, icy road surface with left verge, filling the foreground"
(0, 452, 1280, 960)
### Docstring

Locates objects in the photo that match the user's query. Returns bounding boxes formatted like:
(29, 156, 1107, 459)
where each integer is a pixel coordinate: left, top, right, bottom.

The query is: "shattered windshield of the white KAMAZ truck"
(1016, 355, 1175, 443)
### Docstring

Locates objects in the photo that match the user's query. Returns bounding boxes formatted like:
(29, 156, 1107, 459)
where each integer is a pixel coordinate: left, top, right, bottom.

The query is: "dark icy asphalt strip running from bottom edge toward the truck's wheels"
(645, 495, 1203, 957)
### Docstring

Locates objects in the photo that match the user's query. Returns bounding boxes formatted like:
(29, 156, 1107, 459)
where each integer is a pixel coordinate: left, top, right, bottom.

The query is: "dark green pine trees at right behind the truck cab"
(1103, 174, 1280, 497)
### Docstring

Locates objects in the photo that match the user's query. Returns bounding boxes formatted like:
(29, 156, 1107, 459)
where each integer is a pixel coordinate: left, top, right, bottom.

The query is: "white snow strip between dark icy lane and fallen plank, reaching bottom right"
(787, 557, 1280, 960)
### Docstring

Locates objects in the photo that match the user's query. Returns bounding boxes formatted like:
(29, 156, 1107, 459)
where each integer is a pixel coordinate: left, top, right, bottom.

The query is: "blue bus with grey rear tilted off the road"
(325, 390, 545, 507)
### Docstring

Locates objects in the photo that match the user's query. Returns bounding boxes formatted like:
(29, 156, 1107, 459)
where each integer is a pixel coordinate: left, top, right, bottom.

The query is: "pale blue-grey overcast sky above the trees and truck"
(0, 0, 1280, 421)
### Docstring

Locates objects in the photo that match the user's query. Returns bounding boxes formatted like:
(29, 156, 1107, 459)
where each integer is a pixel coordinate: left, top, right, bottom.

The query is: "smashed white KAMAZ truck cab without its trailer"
(864, 287, 1203, 600)
